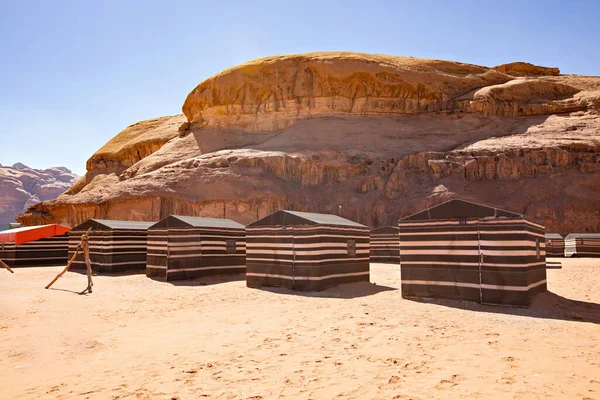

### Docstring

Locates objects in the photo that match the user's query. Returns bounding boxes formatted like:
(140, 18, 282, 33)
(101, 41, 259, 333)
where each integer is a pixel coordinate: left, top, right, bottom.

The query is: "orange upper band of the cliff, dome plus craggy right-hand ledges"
(183, 53, 600, 132)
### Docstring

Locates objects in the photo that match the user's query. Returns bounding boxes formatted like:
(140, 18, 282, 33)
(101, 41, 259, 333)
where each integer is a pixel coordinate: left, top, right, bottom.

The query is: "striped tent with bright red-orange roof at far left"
(0, 224, 69, 267)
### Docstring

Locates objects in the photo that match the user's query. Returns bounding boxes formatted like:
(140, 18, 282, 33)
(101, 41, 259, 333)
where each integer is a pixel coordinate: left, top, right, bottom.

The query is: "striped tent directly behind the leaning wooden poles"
(69, 219, 154, 273)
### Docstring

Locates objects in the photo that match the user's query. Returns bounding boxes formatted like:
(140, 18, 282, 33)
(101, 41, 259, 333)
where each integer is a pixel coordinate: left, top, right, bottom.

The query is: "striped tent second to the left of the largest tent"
(146, 215, 246, 281)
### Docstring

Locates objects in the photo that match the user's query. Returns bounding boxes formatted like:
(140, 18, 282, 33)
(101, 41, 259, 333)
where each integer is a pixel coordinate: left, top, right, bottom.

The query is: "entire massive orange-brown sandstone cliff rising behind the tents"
(20, 53, 600, 232)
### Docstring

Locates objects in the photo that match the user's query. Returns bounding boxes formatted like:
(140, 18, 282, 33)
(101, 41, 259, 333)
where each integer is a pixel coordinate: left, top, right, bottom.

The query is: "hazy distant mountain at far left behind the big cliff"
(0, 163, 79, 230)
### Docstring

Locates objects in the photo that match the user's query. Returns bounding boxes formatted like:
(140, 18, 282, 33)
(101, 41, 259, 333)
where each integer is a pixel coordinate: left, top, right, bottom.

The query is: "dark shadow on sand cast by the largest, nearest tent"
(407, 292, 600, 324)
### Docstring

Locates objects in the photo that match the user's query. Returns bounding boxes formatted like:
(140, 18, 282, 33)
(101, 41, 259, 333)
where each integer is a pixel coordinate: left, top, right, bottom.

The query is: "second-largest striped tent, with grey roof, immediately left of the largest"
(246, 210, 369, 291)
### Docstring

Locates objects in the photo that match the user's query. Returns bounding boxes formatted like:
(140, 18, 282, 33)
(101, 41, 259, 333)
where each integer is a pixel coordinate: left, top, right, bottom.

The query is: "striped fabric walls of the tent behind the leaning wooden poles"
(69, 229, 148, 273)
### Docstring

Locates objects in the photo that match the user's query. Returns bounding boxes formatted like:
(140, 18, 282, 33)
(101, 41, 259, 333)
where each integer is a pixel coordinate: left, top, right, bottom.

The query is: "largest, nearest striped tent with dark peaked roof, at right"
(398, 200, 546, 306)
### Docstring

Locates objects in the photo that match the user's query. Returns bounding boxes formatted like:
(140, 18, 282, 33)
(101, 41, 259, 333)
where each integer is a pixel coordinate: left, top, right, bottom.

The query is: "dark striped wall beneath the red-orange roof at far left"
(0, 234, 69, 267)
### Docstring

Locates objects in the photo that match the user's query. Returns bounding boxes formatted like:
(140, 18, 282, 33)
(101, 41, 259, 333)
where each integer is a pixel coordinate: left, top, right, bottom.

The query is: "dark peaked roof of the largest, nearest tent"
(400, 199, 523, 222)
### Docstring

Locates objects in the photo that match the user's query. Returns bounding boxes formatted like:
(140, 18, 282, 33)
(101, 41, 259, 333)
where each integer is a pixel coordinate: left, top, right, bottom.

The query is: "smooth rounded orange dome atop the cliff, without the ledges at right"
(183, 53, 512, 132)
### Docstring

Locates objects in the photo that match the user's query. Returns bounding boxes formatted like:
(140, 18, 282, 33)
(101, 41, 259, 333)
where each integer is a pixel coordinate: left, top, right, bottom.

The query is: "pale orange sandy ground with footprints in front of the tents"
(0, 259, 600, 399)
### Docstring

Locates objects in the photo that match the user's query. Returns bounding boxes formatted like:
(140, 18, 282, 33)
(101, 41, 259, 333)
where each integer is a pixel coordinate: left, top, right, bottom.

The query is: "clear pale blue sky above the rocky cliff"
(0, 0, 600, 174)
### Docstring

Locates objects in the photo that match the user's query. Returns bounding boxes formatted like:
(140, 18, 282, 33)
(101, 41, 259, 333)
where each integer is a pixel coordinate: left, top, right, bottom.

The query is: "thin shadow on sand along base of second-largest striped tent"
(256, 282, 398, 299)
